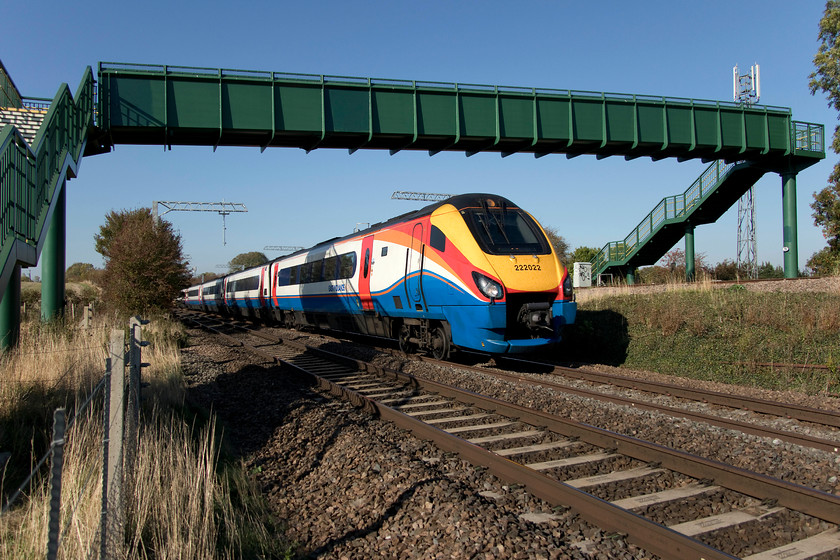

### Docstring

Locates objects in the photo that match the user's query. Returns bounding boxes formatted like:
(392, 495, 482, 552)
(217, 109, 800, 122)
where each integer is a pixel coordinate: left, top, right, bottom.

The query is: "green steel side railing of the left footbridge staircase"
(0, 67, 94, 272)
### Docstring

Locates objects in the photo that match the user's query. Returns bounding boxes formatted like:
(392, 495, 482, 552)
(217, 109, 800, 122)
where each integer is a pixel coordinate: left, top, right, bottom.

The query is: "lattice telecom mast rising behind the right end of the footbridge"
(732, 64, 761, 279)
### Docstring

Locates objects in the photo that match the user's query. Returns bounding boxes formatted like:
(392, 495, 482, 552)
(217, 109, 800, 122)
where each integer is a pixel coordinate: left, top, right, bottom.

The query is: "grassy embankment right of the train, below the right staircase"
(564, 285, 840, 394)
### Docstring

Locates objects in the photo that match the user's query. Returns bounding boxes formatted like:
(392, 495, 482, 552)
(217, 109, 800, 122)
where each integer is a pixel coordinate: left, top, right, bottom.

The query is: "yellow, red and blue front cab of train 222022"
(423, 196, 577, 354)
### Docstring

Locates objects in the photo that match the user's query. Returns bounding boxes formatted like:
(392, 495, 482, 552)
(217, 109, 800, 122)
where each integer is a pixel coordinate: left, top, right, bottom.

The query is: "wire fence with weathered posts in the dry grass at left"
(0, 317, 149, 560)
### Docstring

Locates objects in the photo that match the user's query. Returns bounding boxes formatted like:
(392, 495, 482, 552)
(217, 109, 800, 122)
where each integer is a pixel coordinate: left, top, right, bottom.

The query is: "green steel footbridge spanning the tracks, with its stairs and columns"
(0, 63, 825, 347)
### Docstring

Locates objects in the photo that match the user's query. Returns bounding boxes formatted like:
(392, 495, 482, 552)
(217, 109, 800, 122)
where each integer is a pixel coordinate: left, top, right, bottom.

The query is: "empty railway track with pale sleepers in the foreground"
(177, 310, 840, 560)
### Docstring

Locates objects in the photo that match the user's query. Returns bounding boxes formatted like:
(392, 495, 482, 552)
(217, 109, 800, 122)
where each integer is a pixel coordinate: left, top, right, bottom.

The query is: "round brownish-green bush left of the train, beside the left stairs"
(94, 208, 190, 315)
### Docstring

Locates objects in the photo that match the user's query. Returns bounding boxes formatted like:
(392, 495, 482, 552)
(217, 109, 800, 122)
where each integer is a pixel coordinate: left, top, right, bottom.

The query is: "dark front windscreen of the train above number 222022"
(461, 204, 551, 255)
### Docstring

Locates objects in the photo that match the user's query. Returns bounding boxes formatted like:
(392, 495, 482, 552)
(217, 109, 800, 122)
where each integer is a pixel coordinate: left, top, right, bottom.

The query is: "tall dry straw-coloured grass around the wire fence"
(0, 318, 293, 560)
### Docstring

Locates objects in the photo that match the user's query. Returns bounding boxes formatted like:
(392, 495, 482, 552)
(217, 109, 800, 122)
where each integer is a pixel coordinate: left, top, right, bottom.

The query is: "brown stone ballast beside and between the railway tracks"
(183, 320, 840, 559)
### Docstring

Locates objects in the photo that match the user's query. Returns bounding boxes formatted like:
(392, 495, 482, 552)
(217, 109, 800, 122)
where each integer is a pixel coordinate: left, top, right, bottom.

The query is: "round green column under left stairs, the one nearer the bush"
(41, 181, 67, 321)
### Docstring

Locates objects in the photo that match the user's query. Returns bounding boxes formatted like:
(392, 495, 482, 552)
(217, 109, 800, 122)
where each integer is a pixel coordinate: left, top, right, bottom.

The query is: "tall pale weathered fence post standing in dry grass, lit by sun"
(101, 329, 125, 560)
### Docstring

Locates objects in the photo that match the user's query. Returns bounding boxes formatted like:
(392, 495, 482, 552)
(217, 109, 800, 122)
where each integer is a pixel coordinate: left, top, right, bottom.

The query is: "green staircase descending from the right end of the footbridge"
(592, 161, 767, 276)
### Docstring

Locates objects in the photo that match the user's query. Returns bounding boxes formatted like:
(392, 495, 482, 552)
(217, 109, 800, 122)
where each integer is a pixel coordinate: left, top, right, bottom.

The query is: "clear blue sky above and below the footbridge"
(0, 0, 837, 274)
